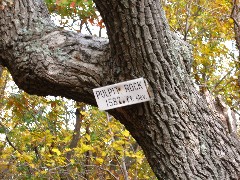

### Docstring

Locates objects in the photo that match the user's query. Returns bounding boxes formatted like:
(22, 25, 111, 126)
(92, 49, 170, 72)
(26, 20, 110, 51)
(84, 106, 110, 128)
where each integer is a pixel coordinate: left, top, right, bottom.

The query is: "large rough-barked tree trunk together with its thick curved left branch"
(0, 0, 240, 180)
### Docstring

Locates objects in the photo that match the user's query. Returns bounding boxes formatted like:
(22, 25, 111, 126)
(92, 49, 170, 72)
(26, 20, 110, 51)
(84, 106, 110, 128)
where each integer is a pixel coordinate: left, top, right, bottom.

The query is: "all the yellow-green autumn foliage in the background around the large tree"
(0, 0, 240, 179)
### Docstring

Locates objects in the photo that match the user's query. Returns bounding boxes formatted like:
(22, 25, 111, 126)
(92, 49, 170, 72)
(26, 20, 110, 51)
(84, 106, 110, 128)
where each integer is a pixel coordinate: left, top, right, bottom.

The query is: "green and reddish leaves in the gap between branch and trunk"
(46, 0, 104, 34)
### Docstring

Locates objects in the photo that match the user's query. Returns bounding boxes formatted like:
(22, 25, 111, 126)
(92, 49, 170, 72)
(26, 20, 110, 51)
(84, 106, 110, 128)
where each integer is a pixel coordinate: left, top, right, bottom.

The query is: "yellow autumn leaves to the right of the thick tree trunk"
(163, 0, 240, 109)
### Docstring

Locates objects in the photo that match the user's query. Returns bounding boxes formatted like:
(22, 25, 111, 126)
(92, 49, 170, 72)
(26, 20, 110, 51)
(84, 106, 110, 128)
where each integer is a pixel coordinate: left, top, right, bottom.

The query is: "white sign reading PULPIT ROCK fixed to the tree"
(93, 78, 150, 110)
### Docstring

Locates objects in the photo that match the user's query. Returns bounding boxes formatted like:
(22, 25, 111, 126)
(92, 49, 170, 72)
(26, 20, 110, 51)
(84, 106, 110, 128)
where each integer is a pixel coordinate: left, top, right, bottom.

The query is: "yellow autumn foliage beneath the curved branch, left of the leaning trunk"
(0, 74, 154, 179)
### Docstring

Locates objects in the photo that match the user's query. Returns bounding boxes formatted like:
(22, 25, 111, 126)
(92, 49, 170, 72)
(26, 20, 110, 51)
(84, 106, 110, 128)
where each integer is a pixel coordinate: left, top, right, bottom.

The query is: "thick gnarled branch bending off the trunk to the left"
(0, 0, 109, 105)
